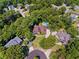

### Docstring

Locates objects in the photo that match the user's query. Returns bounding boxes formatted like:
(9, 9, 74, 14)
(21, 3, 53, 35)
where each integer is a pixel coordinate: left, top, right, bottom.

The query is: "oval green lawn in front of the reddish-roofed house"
(39, 36, 57, 49)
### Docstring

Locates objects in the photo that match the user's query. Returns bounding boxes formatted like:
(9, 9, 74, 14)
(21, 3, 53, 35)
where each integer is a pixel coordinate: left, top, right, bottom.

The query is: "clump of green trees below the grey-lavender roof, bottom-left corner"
(0, 45, 28, 59)
